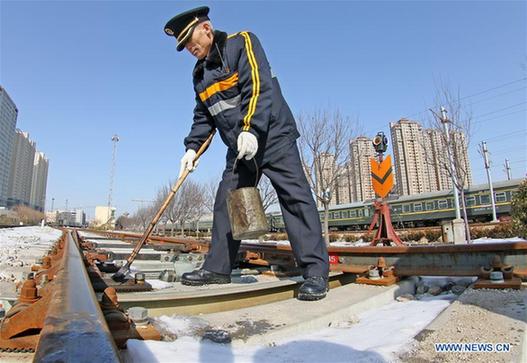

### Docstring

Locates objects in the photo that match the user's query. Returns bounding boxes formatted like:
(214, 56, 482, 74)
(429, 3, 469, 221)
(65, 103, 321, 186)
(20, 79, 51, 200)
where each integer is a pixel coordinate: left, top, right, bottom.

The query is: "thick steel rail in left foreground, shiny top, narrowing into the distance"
(34, 232, 120, 362)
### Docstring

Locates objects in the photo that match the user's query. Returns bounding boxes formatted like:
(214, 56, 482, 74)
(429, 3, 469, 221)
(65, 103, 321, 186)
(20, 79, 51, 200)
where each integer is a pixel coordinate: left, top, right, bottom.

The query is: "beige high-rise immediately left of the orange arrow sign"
(350, 136, 375, 202)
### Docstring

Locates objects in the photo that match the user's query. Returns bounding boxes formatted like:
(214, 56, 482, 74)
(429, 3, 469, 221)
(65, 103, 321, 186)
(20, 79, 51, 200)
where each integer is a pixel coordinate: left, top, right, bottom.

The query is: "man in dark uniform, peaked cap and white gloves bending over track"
(165, 6, 329, 300)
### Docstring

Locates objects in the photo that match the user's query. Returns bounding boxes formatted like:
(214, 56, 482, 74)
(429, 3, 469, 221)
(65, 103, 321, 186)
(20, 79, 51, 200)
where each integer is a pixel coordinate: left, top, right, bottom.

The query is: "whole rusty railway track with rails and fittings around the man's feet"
(0, 231, 527, 362)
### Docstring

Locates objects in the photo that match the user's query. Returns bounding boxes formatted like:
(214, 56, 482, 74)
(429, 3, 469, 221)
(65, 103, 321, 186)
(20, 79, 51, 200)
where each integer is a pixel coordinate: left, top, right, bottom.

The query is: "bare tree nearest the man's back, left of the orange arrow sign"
(298, 110, 357, 246)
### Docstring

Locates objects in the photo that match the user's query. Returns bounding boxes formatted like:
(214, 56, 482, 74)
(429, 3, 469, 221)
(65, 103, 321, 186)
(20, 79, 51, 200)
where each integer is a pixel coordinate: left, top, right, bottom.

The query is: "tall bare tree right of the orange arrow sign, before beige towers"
(425, 83, 472, 243)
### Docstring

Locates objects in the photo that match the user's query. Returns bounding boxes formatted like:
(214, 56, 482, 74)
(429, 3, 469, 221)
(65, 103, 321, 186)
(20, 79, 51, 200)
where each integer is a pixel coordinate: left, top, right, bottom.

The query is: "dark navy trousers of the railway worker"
(203, 142, 329, 278)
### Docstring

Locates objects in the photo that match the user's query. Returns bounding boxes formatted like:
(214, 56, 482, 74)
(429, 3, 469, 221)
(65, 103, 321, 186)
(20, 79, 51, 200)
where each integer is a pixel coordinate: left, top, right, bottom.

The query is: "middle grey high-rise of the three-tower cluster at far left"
(7, 130, 36, 206)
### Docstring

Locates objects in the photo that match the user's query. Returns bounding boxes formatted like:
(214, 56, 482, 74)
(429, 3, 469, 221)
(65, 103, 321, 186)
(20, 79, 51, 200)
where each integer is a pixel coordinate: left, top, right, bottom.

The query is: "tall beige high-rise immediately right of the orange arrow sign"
(390, 118, 430, 195)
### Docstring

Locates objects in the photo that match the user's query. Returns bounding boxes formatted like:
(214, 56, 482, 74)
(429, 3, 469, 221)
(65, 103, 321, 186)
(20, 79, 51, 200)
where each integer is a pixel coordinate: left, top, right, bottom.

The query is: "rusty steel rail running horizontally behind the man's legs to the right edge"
(87, 233, 527, 278)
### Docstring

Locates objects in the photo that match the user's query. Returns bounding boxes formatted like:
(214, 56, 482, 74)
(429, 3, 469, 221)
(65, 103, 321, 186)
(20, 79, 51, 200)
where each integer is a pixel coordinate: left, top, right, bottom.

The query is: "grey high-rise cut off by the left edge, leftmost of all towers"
(0, 86, 18, 207)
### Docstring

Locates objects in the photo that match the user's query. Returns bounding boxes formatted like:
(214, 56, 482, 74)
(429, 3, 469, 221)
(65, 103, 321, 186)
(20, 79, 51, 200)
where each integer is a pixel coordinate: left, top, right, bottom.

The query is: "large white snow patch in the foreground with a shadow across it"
(123, 295, 454, 363)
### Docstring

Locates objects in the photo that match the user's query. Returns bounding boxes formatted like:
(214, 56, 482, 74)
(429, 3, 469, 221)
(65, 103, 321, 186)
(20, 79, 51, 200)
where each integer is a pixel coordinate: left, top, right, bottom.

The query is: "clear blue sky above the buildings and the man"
(0, 0, 527, 215)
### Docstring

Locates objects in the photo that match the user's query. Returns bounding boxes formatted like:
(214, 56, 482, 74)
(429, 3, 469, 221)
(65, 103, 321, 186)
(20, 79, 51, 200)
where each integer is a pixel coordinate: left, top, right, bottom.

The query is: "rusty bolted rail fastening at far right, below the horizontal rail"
(474, 255, 522, 290)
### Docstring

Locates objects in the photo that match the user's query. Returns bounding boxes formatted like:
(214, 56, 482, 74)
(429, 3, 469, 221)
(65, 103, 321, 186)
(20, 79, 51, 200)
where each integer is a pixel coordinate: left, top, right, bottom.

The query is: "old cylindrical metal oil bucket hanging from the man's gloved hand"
(227, 159, 269, 240)
